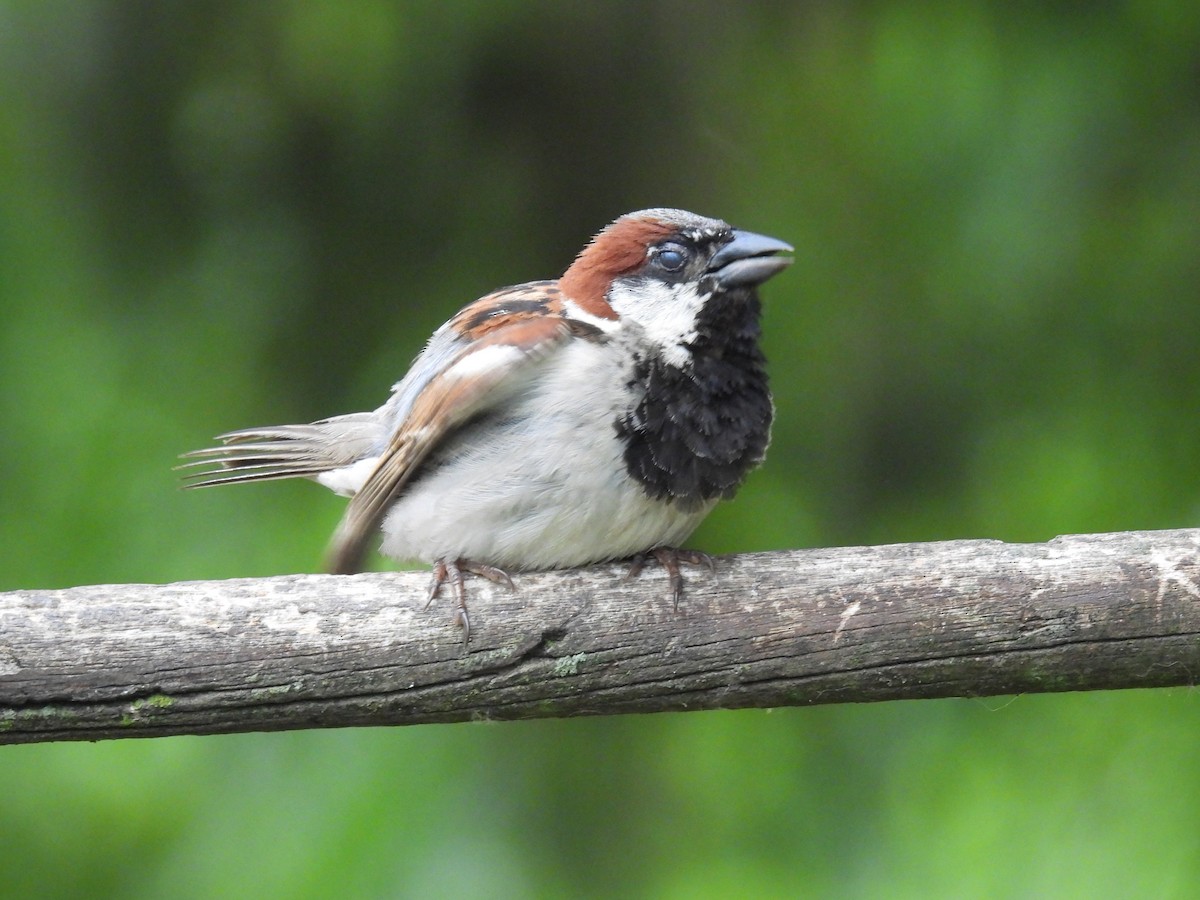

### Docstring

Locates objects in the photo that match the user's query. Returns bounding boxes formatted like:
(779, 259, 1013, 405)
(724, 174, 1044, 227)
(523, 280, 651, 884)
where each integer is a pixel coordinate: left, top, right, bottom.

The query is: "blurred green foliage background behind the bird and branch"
(0, 0, 1200, 898)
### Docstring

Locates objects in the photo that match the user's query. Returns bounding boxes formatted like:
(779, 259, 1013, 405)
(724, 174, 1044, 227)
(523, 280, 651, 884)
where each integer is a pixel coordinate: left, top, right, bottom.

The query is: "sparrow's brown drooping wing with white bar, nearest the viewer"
(328, 314, 578, 575)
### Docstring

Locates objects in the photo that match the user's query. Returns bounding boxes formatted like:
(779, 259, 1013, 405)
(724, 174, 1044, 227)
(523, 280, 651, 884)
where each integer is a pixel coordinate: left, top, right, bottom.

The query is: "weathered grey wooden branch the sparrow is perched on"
(0, 529, 1200, 743)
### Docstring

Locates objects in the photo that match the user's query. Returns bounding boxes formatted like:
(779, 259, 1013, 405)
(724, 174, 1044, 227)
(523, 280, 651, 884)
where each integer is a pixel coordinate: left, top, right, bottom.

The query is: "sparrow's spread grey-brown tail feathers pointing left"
(176, 413, 383, 487)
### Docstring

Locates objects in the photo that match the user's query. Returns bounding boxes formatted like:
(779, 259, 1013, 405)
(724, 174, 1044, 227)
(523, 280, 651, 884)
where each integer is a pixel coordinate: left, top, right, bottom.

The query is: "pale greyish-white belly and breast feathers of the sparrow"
(380, 340, 715, 570)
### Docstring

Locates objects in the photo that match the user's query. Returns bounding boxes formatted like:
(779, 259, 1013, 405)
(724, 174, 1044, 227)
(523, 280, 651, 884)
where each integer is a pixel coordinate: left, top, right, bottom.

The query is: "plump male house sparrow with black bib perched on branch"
(182, 209, 792, 642)
